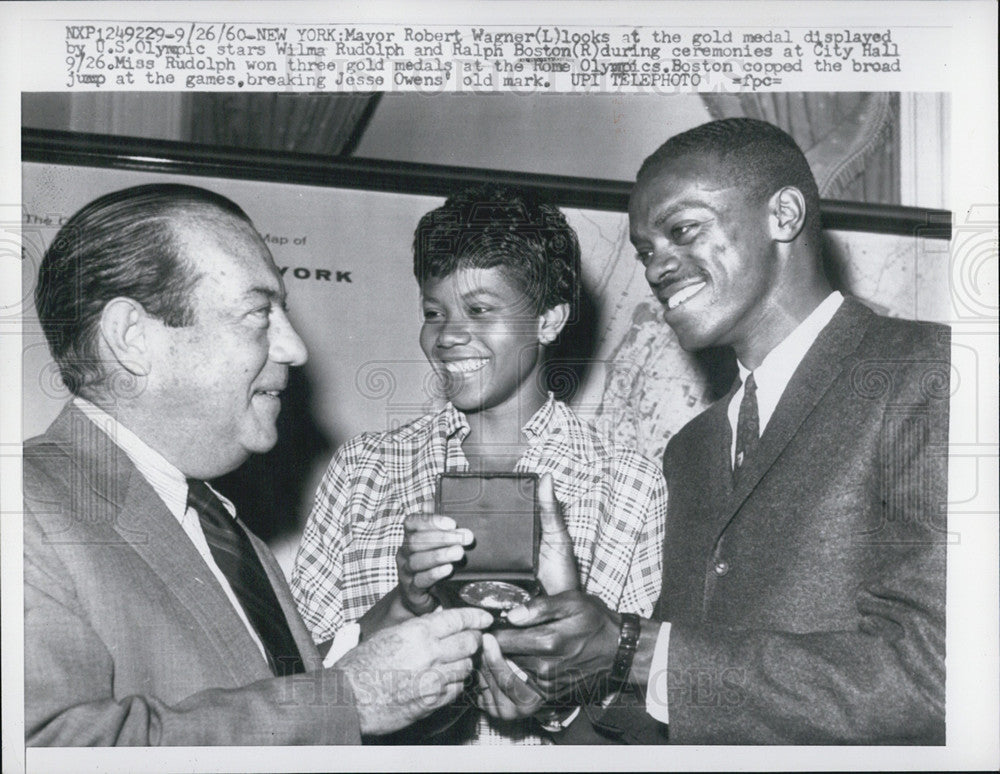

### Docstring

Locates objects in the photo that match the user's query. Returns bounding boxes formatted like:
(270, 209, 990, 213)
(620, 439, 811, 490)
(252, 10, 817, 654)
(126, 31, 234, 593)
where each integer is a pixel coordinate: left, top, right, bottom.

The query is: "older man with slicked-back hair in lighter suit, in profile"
(24, 185, 491, 745)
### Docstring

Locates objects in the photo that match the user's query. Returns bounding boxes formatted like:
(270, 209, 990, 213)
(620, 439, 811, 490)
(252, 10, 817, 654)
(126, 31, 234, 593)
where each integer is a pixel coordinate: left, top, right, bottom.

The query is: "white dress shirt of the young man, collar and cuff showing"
(646, 291, 844, 723)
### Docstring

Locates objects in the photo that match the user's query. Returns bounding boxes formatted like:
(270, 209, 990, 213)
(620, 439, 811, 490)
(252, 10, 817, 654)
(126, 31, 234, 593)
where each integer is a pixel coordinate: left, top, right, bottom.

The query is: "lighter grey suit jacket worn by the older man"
(24, 405, 360, 746)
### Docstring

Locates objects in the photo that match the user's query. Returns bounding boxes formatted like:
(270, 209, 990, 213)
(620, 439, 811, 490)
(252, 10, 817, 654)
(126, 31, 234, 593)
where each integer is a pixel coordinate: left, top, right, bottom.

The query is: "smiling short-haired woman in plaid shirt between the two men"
(292, 185, 666, 744)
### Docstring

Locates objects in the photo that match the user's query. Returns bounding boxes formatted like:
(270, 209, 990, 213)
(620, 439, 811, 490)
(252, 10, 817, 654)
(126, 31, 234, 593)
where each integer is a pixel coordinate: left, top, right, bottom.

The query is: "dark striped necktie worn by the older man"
(188, 478, 305, 676)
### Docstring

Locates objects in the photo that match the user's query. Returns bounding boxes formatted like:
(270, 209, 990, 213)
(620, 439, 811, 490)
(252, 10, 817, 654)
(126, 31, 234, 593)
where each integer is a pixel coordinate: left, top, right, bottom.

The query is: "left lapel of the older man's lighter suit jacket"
(53, 406, 271, 685)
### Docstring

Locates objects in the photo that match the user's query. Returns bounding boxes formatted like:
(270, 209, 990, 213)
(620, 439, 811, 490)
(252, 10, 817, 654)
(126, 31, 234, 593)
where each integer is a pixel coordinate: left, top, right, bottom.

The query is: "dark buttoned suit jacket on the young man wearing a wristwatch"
(580, 299, 950, 744)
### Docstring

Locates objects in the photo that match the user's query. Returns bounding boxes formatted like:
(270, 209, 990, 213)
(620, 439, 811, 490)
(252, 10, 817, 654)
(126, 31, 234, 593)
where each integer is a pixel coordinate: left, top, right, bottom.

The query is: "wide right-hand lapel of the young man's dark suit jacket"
(720, 298, 875, 534)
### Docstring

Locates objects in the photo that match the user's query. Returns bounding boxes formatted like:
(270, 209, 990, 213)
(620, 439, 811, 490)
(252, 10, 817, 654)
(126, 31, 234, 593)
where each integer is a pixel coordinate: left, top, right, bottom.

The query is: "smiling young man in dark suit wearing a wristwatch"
(487, 119, 950, 744)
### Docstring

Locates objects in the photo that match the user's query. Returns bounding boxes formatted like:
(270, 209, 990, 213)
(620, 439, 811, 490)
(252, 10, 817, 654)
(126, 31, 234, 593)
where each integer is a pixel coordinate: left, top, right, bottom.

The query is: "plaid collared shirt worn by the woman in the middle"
(291, 397, 667, 741)
